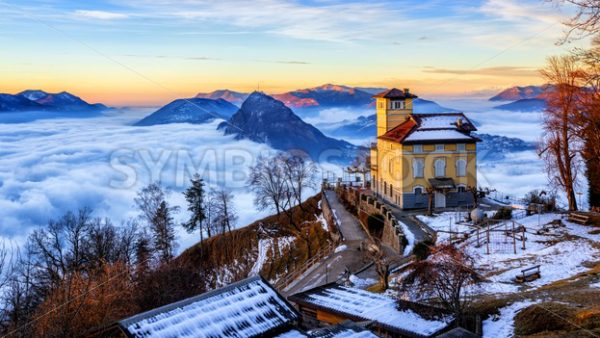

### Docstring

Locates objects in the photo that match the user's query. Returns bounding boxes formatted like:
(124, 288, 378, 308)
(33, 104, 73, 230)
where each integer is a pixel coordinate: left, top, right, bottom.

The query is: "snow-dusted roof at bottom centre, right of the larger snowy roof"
(289, 284, 453, 337)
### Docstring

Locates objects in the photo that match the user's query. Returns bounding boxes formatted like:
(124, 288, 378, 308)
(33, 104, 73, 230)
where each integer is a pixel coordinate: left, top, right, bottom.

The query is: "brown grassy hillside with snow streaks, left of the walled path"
(176, 194, 331, 289)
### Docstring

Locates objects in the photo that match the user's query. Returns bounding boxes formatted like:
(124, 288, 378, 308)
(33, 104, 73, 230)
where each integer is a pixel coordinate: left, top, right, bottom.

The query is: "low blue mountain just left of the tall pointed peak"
(135, 98, 238, 126)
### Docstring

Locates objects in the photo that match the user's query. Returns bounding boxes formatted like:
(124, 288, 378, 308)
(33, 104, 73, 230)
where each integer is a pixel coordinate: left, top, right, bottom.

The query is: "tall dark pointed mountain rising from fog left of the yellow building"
(219, 92, 356, 161)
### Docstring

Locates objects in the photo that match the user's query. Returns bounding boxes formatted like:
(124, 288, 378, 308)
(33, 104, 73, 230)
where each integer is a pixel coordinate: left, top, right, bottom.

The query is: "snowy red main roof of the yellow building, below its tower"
(380, 113, 480, 144)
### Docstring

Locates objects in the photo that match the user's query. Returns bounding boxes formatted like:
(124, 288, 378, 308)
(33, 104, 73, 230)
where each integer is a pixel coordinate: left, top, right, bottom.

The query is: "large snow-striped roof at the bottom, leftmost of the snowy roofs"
(119, 277, 299, 338)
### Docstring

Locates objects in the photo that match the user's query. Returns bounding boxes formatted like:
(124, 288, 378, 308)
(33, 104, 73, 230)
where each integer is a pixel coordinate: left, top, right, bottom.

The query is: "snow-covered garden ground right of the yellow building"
(419, 212, 600, 294)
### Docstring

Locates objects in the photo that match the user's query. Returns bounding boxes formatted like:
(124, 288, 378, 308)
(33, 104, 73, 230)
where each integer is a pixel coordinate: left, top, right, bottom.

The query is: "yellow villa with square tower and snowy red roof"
(371, 88, 480, 209)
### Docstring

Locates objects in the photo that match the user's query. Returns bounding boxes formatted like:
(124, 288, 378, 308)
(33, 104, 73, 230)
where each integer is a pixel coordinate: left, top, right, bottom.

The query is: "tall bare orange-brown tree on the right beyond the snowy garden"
(540, 56, 582, 210)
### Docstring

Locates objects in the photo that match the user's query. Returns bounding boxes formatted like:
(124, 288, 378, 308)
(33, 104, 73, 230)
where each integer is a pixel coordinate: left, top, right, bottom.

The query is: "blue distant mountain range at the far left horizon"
(0, 90, 109, 113)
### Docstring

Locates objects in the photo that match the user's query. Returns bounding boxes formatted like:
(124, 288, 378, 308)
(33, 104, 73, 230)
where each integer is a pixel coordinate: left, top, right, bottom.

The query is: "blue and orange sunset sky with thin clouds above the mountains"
(0, 0, 586, 106)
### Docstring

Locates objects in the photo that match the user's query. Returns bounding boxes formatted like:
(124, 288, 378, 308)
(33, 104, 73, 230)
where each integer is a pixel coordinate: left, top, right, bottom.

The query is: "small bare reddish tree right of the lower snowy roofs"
(402, 244, 481, 323)
